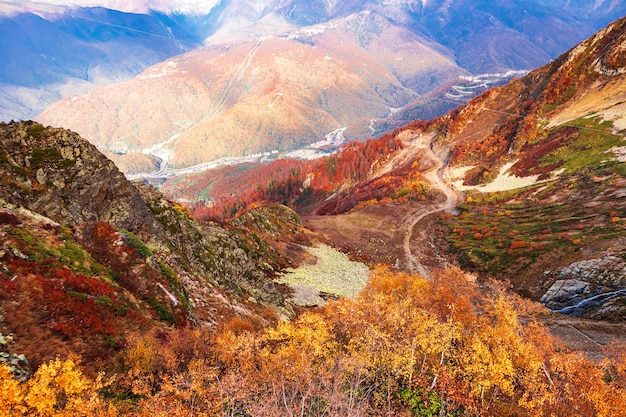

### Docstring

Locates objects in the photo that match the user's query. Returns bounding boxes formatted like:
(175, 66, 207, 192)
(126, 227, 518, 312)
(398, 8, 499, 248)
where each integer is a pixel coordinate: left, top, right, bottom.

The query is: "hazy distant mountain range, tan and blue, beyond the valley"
(0, 1, 626, 174)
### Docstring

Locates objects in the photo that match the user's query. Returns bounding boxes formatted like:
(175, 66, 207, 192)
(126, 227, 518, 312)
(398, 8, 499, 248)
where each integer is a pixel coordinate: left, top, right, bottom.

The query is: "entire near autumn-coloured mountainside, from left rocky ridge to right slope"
(0, 13, 626, 416)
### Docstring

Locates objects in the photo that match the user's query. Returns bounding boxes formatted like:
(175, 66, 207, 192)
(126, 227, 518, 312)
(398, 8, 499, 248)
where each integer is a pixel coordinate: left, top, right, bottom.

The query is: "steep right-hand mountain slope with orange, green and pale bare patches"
(424, 14, 626, 319)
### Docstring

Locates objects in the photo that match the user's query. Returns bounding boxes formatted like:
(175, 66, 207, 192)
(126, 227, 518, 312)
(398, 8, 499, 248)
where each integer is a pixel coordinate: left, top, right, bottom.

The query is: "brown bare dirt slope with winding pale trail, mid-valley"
(303, 131, 464, 277)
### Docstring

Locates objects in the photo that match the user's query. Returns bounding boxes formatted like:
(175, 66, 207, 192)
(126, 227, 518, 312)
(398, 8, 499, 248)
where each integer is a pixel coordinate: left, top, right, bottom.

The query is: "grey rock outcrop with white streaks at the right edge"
(540, 256, 626, 319)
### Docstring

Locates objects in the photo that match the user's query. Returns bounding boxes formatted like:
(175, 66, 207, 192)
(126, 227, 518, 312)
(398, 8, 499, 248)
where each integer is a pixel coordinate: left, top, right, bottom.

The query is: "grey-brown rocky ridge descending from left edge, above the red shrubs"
(0, 122, 291, 325)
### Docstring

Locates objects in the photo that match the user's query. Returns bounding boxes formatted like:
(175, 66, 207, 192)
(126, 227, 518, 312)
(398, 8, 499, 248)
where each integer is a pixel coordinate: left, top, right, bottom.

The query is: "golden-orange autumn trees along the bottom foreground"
(0, 267, 626, 416)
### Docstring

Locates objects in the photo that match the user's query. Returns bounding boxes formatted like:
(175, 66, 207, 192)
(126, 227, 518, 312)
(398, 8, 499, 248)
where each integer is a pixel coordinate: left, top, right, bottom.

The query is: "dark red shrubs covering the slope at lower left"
(0, 219, 185, 371)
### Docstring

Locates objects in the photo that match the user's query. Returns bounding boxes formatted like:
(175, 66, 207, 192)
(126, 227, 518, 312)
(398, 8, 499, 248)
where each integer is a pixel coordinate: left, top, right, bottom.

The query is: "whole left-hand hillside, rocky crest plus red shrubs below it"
(0, 118, 308, 365)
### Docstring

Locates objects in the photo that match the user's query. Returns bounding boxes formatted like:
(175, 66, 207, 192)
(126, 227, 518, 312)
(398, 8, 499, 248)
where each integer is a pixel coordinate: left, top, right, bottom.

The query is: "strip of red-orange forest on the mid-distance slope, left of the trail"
(162, 135, 404, 219)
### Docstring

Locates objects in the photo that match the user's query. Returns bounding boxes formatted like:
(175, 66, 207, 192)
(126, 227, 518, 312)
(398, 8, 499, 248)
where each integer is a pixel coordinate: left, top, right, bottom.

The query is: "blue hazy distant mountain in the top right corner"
(402, 0, 626, 74)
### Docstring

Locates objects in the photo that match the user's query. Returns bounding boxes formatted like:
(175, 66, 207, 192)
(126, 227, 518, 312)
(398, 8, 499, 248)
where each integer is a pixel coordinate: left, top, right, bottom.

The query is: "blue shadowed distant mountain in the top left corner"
(0, 8, 200, 121)
